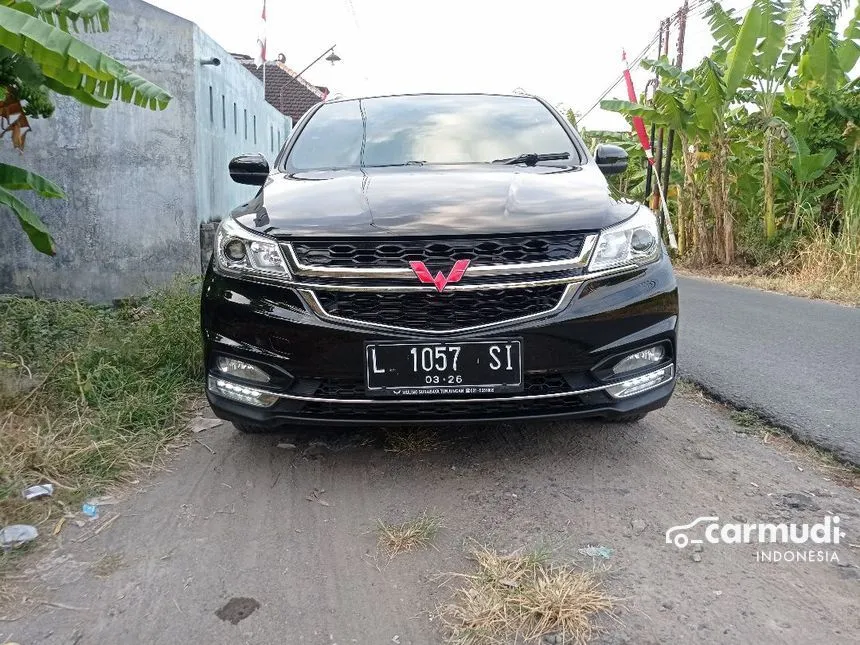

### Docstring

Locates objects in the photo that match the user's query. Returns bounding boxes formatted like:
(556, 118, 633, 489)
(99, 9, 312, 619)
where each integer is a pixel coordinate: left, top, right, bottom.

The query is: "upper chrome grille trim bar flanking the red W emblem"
(280, 234, 598, 280)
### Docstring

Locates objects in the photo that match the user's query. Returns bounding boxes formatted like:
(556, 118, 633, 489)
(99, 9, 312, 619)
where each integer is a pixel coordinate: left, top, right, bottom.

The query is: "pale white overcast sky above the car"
(147, 0, 751, 130)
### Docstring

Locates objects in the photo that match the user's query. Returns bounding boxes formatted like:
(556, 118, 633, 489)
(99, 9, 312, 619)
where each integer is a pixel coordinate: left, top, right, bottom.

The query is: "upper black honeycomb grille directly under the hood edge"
(292, 233, 585, 271)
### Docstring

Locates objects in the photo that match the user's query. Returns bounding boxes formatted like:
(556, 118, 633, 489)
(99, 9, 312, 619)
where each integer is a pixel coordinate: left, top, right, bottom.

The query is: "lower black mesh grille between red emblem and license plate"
(315, 285, 566, 331)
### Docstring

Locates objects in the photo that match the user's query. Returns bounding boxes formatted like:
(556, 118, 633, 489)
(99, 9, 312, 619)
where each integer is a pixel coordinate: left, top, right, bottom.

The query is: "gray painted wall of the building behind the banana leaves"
(0, 0, 290, 302)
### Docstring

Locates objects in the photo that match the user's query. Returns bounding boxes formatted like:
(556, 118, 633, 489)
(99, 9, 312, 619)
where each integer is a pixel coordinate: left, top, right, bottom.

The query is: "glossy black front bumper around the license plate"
(201, 256, 678, 426)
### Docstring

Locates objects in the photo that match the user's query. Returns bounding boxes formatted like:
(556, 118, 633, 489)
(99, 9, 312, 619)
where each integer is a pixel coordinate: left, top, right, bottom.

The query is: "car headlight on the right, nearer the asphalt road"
(588, 206, 661, 271)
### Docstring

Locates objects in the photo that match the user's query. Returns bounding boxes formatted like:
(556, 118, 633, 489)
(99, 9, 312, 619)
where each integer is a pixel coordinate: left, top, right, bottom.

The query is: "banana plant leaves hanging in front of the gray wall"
(0, 0, 171, 255)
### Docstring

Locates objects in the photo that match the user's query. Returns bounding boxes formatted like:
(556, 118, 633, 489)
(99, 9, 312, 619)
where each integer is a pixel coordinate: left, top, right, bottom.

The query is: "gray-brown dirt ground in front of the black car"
(0, 392, 860, 645)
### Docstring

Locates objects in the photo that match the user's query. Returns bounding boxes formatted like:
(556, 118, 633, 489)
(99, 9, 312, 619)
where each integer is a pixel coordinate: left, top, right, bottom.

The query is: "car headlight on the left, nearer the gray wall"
(215, 216, 290, 279)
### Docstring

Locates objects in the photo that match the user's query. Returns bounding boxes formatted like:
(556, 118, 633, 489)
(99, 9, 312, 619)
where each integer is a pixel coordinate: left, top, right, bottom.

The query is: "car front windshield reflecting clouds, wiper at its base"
(286, 95, 581, 173)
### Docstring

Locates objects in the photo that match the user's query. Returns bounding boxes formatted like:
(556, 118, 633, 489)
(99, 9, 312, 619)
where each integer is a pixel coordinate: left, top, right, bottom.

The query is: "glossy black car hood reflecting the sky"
(233, 164, 639, 238)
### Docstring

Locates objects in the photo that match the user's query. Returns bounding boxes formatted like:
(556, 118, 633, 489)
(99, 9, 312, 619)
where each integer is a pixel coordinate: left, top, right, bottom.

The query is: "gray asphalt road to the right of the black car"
(678, 277, 860, 465)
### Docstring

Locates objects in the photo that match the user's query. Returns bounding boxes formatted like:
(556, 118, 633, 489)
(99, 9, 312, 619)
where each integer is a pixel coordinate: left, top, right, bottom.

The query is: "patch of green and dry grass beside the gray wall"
(0, 280, 202, 534)
